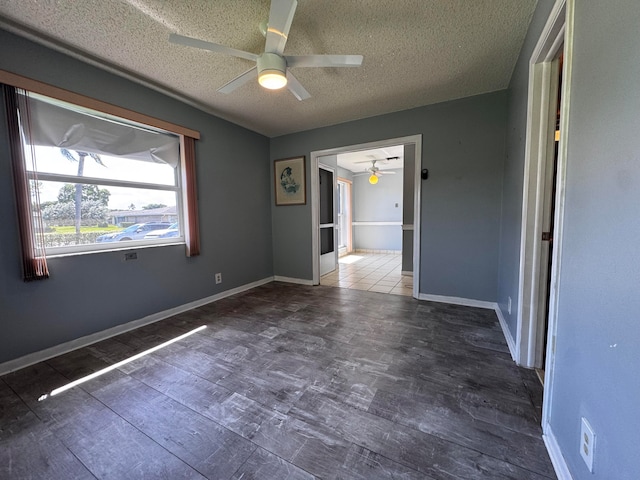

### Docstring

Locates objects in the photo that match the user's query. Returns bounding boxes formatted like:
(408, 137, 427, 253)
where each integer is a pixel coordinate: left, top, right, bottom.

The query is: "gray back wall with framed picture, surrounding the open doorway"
(271, 92, 506, 301)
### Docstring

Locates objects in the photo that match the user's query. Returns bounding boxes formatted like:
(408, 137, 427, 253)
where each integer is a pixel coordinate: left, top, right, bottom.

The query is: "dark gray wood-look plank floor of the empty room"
(0, 283, 555, 480)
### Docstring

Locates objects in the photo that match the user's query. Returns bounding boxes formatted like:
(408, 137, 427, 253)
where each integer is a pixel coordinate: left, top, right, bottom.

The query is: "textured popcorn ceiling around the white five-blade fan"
(0, 0, 536, 137)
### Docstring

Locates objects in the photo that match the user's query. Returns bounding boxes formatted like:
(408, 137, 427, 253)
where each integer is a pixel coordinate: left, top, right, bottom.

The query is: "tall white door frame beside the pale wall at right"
(515, 0, 575, 446)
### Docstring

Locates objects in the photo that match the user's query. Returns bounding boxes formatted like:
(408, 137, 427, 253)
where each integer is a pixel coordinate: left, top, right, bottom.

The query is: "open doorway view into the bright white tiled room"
(320, 145, 413, 296)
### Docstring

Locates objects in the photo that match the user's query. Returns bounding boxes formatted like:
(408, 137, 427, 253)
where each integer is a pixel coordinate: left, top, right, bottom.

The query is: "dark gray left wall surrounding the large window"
(0, 31, 273, 363)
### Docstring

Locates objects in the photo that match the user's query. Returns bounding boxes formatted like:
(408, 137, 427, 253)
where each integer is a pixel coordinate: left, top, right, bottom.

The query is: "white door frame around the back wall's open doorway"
(310, 135, 422, 298)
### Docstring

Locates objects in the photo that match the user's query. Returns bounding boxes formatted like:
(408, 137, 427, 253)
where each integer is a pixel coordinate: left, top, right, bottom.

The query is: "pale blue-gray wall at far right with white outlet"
(551, 0, 640, 480)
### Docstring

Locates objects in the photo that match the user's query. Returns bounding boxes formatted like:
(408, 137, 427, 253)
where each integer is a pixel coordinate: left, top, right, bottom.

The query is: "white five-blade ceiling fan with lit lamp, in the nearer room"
(169, 0, 362, 100)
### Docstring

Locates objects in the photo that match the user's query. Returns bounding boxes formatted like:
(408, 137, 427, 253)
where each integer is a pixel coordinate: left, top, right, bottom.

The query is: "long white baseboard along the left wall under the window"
(0, 277, 274, 375)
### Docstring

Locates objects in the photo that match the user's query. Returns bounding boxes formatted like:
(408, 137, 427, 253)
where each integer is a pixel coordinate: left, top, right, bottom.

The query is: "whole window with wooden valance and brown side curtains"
(0, 70, 200, 281)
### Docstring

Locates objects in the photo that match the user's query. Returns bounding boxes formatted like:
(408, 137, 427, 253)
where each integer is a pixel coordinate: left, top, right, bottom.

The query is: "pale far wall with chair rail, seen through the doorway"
(353, 168, 403, 251)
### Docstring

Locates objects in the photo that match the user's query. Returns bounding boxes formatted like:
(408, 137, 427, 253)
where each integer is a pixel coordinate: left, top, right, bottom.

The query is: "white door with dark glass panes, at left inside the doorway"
(318, 165, 338, 276)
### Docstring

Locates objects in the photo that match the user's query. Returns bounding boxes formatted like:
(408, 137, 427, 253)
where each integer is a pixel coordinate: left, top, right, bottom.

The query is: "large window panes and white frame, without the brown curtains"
(20, 93, 190, 255)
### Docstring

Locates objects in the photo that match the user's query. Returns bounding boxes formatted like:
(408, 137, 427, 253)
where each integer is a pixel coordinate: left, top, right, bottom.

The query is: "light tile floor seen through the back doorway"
(320, 252, 413, 297)
